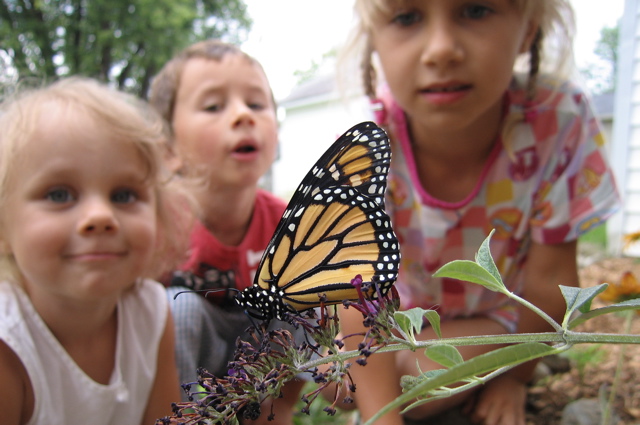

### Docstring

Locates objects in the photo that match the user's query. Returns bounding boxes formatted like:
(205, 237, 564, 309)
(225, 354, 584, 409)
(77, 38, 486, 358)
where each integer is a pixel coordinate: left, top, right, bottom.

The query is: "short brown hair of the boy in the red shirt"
(149, 40, 276, 137)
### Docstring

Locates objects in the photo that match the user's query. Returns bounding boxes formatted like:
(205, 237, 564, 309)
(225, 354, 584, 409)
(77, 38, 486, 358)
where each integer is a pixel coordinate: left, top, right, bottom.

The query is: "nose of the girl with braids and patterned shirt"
(422, 20, 464, 68)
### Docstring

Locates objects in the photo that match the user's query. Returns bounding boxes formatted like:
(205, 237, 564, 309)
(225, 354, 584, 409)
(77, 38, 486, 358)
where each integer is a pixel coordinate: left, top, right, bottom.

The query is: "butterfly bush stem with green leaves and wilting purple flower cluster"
(164, 235, 640, 425)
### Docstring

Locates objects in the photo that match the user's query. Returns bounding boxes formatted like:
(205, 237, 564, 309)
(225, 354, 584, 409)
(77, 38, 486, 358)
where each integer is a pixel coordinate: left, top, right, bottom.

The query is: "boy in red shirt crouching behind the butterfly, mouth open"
(149, 40, 302, 423)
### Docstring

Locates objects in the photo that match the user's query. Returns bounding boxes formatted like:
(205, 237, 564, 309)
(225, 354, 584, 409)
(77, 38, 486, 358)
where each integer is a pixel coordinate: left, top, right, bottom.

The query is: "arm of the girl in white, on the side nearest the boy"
(142, 306, 180, 425)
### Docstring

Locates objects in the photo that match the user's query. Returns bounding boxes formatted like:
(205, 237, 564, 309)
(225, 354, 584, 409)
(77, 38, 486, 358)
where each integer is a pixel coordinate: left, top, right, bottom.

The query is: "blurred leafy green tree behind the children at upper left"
(0, 0, 251, 96)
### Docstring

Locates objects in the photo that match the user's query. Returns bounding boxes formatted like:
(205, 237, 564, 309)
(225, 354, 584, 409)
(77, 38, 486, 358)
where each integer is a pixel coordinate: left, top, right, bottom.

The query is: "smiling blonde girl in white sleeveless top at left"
(0, 78, 188, 425)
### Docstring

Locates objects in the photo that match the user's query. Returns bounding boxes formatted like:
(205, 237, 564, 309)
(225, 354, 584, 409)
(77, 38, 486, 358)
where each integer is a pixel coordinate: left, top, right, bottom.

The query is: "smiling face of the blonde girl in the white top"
(6, 105, 156, 301)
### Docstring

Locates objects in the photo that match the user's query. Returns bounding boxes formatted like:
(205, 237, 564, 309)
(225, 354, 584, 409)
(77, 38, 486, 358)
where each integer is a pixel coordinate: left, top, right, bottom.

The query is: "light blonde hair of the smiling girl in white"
(0, 77, 191, 282)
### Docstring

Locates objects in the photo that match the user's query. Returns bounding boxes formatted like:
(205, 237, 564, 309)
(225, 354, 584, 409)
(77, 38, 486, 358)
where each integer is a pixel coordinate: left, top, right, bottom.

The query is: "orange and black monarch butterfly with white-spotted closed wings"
(236, 122, 400, 320)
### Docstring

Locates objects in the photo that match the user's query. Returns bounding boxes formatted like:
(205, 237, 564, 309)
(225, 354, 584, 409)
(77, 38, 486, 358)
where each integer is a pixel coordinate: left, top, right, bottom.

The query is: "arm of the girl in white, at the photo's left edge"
(0, 340, 34, 425)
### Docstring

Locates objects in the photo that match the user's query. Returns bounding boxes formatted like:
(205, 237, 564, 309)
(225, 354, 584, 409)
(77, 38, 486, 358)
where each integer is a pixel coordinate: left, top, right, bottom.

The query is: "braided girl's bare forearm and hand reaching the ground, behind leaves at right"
(474, 241, 579, 425)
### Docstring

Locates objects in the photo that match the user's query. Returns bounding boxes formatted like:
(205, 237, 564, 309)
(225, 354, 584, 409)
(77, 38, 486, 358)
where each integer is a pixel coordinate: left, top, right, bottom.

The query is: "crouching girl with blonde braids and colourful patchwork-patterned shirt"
(342, 0, 619, 425)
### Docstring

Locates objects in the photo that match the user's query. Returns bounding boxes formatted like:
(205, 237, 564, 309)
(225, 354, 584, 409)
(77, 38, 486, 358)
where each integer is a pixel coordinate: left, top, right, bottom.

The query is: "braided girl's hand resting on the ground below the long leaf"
(471, 374, 527, 425)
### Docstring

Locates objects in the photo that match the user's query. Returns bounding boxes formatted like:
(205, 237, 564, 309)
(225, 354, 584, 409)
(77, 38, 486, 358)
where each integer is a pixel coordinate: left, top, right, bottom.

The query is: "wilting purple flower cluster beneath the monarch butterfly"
(157, 275, 399, 425)
